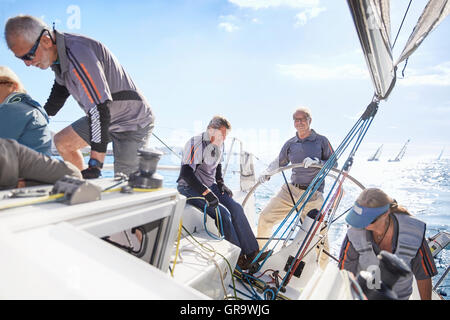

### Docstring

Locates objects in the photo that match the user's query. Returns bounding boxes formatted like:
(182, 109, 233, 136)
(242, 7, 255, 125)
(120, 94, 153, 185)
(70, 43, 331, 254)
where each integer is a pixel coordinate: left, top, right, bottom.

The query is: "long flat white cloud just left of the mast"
(277, 64, 369, 80)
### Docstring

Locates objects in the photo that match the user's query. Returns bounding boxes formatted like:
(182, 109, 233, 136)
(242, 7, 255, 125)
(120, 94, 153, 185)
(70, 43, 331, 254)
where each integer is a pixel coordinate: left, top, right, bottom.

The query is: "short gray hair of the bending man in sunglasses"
(5, 15, 50, 49)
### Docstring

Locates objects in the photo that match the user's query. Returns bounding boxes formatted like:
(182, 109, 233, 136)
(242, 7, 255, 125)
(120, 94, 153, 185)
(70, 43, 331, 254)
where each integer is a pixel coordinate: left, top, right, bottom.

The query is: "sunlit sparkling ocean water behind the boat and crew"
(106, 155, 450, 300)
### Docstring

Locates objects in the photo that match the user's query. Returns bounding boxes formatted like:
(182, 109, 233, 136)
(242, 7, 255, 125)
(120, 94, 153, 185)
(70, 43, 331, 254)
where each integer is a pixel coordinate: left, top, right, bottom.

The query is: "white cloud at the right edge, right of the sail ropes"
(397, 61, 450, 87)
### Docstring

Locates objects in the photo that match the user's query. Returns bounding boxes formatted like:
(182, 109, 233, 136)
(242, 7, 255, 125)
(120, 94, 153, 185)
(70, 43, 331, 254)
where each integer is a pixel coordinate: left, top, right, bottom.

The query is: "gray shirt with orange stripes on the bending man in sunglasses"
(52, 31, 154, 133)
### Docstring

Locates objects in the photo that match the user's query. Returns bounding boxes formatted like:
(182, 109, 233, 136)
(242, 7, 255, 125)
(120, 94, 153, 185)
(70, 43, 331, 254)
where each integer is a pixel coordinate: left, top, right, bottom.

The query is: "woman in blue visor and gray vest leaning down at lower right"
(339, 188, 437, 300)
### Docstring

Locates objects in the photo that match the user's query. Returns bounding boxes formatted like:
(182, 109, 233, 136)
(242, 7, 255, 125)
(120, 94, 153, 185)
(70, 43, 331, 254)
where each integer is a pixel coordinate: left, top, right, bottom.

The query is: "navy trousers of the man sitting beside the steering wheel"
(178, 184, 259, 254)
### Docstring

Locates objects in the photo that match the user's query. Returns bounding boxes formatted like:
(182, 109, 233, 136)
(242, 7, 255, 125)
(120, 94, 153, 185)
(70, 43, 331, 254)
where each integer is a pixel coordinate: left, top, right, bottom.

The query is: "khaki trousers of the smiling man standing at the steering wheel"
(257, 184, 329, 269)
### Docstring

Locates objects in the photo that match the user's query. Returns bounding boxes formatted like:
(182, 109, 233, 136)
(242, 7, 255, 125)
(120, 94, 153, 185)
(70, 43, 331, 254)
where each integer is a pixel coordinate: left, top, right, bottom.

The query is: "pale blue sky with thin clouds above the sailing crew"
(0, 0, 450, 158)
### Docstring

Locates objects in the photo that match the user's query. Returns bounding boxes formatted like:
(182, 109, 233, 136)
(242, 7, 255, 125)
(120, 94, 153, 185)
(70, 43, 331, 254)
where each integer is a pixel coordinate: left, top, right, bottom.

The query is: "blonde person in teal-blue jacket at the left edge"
(0, 66, 52, 156)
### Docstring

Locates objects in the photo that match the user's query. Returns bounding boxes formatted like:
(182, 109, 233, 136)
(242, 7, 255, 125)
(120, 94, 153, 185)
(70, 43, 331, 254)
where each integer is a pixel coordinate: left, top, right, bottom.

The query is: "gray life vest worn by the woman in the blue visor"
(347, 213, 426, 300)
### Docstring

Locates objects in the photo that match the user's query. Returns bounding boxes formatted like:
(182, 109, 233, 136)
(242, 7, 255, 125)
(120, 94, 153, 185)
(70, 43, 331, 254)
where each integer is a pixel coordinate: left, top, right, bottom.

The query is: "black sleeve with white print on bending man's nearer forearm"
(88, 100, 111, 153)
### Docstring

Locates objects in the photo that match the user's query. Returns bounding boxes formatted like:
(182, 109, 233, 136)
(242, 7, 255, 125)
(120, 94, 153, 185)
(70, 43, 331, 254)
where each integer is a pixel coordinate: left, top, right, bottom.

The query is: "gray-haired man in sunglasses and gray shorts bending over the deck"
(5, 15, 154, 179)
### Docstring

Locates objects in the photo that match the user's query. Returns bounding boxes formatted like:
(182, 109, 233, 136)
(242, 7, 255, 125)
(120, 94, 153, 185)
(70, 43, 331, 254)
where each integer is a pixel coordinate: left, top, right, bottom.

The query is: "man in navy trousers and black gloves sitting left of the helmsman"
(177, 116, 267, 270)
